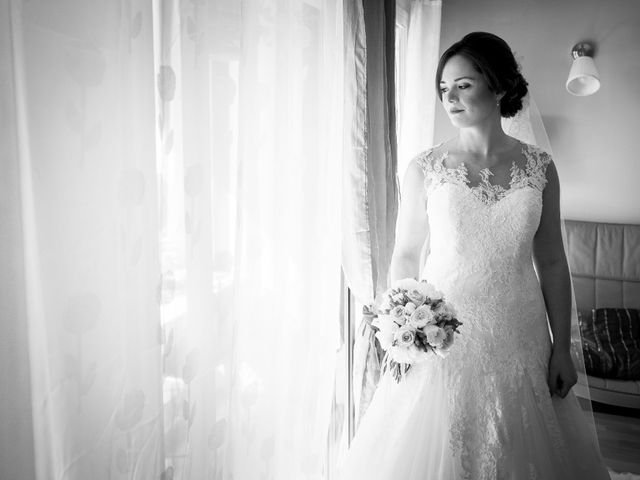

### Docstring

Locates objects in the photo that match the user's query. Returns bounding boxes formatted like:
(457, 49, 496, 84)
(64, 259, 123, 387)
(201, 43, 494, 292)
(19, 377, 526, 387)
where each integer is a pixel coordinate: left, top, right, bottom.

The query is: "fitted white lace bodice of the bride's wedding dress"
(417, 144, 551, 306)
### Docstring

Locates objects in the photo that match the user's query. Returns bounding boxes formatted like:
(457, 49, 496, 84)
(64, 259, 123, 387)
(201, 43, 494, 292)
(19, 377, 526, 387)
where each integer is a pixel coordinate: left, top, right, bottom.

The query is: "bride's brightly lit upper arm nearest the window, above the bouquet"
(389, 159, 429, 283)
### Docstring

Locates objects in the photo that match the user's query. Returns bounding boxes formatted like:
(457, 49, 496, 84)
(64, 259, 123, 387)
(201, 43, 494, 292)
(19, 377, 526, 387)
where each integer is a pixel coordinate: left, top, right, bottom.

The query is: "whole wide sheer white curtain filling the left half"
(0, 0, 351, 480)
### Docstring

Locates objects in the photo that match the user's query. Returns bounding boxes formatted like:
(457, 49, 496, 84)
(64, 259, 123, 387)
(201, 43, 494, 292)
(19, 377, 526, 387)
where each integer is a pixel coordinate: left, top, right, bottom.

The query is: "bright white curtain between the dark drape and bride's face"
(396, 0, 442, 180)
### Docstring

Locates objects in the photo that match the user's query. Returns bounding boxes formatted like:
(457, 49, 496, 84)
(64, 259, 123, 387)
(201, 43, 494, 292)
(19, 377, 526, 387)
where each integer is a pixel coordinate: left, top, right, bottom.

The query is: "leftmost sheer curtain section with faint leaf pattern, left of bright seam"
(9, 1, 162, 478)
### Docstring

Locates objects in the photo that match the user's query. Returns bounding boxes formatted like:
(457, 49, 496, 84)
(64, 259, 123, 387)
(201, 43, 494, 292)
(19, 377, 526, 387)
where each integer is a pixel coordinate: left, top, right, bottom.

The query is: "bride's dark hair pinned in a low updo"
(436, 32, 528, 118)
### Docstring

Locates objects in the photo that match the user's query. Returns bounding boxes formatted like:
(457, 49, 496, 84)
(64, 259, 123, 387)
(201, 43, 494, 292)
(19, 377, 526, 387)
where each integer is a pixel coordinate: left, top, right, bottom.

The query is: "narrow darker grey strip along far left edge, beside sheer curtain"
(0, 0, 35, 480)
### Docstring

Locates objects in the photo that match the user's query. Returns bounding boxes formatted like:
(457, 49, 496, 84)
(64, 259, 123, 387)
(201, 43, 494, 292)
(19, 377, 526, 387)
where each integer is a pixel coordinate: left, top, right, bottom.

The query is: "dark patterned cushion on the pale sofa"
(580, 308, 640, 380)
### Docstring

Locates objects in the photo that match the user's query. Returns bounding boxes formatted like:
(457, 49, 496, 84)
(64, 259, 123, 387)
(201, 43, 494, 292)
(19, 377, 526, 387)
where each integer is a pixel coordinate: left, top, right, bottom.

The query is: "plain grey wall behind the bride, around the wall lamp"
(436, 0, 640, 224)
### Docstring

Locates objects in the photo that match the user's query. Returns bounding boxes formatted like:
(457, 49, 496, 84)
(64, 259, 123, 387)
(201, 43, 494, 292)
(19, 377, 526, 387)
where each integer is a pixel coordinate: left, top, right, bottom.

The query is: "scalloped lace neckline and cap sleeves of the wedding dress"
(416, 143, 551, 205)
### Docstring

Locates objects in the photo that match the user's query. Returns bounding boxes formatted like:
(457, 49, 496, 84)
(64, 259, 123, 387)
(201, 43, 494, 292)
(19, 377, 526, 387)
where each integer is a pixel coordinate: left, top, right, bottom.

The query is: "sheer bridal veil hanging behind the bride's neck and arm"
(502, 91, 599, 449)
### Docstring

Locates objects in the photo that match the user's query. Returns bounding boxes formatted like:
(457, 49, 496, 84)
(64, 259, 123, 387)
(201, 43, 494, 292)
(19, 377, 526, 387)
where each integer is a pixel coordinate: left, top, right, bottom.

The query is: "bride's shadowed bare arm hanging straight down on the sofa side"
(533, 162, 578, 398)
